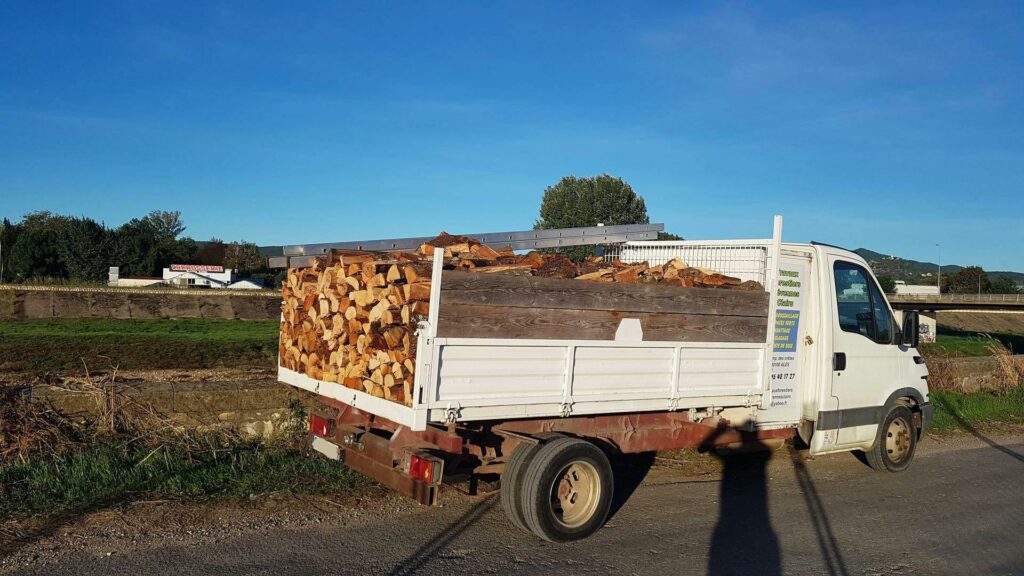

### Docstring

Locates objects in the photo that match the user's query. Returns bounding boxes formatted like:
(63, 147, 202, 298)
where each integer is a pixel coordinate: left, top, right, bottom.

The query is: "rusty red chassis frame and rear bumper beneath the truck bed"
(310, 397, 796, 505)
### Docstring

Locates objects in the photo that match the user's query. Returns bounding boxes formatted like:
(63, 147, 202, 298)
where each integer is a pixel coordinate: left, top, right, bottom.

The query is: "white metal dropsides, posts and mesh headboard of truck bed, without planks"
(278, 216, 781, 430)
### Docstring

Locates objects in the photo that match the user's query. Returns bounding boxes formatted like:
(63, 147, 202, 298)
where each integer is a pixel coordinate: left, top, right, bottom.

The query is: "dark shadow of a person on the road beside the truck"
(700, 427, 782, 576)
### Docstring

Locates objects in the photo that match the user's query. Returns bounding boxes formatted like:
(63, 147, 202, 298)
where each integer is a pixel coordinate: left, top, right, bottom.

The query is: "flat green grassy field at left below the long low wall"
(0, 320, 278, 372)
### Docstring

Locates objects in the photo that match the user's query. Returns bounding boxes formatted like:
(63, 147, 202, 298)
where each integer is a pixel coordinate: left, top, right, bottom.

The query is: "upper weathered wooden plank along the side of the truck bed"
(440, 271, 768, 318)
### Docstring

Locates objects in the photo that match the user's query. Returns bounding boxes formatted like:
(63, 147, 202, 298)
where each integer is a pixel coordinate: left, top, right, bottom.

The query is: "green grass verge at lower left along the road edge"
(0, 440, 369, 519)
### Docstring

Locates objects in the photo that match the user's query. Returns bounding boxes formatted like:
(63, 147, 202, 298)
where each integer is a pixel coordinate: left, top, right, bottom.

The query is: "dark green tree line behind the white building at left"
(0, 210, 272, 282)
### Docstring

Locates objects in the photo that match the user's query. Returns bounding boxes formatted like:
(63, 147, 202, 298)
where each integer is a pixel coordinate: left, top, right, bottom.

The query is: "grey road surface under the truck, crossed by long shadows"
(0, 437, 1024, 576)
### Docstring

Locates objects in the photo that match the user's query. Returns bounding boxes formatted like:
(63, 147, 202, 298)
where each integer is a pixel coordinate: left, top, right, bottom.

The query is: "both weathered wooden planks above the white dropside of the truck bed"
(437, 271, 768, 342)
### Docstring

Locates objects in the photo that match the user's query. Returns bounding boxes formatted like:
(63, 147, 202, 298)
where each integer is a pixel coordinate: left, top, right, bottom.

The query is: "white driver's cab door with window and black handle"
(831, 257, 899, 448)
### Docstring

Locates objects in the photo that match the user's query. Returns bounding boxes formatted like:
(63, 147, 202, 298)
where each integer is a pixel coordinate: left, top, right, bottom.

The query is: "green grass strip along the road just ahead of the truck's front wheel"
(929, 386, 1024, 430)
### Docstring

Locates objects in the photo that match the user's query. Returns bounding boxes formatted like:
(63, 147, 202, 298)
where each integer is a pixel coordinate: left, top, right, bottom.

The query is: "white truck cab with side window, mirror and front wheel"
(791, 244, 932, 471)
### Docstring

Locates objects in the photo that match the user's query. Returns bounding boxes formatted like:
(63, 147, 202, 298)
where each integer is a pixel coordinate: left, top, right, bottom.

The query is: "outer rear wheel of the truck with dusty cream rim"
(521, 438, 614, 542)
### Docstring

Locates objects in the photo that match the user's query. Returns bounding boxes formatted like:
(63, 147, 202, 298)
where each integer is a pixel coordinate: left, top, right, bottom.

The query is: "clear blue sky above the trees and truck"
(0, 1, 1024, 271)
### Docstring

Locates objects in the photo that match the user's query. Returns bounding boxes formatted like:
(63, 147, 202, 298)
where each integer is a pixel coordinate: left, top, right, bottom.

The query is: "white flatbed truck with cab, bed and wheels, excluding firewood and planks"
(271, 216, 932, 541)
